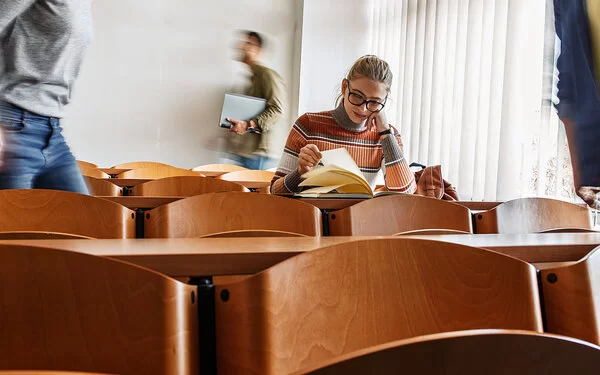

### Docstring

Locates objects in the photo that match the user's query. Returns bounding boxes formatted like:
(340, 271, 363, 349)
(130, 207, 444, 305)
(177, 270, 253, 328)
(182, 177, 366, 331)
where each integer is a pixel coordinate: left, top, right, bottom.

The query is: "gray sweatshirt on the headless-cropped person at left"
(0, 0, 92, 118)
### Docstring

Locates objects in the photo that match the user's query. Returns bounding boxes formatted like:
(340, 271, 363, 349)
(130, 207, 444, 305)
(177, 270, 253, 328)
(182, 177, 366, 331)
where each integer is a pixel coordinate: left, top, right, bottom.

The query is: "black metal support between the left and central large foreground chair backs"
(189, 276, 217, 375)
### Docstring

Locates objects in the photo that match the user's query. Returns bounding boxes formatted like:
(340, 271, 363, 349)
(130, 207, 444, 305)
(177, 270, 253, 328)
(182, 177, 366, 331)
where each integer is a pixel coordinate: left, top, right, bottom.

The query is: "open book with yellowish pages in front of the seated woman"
(295, 148, 395, 198)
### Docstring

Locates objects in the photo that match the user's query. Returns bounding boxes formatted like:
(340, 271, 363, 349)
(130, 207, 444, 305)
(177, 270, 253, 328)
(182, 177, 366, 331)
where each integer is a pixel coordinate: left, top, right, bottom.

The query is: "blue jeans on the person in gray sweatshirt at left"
(0, 102, 89, 194)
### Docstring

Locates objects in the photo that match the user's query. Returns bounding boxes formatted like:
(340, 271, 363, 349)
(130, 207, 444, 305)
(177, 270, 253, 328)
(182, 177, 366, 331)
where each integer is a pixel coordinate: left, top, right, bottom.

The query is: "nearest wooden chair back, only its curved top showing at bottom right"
(298, 330, 600, 375)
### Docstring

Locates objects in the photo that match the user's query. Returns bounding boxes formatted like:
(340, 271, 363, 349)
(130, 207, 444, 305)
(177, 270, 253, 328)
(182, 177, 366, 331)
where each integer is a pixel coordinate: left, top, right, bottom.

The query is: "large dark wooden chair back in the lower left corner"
(0, 244, 199, 375)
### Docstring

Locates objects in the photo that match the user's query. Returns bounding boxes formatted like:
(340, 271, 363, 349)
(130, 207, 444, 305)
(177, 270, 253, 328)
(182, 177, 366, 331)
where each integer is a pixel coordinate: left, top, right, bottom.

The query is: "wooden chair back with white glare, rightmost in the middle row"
(475, 198, 592, 233)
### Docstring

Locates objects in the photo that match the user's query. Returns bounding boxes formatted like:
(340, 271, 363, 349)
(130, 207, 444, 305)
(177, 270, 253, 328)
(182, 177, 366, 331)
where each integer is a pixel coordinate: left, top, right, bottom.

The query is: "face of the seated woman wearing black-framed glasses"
(342, 77, 387, 123)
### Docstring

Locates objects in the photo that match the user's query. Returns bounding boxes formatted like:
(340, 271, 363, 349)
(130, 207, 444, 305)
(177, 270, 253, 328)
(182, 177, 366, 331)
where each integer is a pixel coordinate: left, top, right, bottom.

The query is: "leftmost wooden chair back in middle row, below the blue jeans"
(0, 189, 135, 238)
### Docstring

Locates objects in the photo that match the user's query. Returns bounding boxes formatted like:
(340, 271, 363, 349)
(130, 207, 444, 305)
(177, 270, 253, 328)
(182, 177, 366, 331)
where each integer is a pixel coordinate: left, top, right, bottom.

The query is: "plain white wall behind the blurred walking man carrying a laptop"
(64, 0, 301, 168)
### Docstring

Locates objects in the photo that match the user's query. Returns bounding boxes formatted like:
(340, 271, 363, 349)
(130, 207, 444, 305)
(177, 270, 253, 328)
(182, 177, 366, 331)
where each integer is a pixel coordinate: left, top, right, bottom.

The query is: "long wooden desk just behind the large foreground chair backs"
(0, 233, 600, 277)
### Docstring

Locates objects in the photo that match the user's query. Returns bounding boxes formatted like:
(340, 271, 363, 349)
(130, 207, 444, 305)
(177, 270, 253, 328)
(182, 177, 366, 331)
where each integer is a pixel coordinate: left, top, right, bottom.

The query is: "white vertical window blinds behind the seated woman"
(365, 0, 573, 201)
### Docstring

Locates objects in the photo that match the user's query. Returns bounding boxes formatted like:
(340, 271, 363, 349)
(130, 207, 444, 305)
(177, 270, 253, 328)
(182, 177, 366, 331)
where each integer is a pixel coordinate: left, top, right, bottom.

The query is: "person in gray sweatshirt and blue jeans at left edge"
(0, 0, 92, 194)
